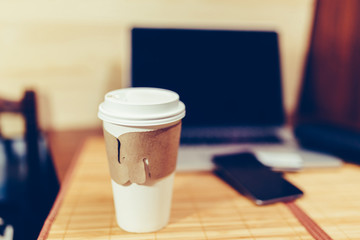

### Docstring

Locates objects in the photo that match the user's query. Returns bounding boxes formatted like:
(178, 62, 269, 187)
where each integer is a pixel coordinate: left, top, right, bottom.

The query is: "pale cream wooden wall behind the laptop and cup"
(0, 0, 314, 129)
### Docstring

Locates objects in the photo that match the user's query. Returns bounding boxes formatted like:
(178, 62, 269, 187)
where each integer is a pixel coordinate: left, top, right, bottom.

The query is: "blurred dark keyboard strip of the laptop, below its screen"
(180, 129, 282, 145)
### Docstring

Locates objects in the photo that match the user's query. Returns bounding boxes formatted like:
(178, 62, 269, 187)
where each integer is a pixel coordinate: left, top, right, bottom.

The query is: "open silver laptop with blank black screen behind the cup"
(131, 28, 344, 170)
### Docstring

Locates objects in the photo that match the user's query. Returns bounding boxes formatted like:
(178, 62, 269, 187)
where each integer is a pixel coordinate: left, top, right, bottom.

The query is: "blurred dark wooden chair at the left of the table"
(0, 91, 59, 240)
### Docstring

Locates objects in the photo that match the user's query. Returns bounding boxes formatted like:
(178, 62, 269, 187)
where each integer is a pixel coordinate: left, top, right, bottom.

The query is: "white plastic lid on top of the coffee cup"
(98, 88, 185, 126)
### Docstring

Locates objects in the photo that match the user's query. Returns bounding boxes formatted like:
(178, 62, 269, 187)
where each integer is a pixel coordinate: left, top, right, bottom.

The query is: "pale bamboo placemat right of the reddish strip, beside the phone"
(287, 164, 360, 239)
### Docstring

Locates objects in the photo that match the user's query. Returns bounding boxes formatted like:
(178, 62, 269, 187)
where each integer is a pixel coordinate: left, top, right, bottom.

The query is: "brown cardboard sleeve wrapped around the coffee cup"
(104, 123, 181, 185)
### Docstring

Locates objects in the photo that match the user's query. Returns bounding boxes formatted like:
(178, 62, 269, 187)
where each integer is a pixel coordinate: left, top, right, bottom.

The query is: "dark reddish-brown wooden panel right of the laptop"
(300, 0, 360, 129)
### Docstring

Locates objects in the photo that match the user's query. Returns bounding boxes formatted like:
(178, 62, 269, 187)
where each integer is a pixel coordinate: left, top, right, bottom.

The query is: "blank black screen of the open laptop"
(131, 28, 284, 126)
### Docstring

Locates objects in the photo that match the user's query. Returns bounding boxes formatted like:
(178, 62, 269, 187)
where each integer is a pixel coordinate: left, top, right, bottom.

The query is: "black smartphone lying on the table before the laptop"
(213, 152, 303, 205)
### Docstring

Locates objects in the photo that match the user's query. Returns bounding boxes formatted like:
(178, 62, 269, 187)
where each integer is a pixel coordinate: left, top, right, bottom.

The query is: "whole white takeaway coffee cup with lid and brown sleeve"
(98, 88, 185, 232)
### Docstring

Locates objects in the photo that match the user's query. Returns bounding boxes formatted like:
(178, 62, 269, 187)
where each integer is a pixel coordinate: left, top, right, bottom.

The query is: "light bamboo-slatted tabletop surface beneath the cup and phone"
(39, 137, 360, 240)
